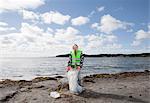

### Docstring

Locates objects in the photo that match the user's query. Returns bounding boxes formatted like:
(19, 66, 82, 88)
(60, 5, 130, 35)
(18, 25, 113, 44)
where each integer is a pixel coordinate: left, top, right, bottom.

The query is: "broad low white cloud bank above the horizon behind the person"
(0, 23, 121, 56)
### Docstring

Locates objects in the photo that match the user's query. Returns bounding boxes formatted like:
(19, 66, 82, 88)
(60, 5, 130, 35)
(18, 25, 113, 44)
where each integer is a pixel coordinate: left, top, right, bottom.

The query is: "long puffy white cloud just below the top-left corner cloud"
(20, 10, 71, 25)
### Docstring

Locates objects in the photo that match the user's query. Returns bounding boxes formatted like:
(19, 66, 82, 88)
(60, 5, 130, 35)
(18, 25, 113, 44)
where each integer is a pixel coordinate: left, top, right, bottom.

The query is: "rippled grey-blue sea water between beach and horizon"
(0, 57, 150, 80)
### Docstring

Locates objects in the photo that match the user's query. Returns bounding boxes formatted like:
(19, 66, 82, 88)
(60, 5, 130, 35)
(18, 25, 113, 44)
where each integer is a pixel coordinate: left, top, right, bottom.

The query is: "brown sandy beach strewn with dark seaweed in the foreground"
(0, 70, 150, 103)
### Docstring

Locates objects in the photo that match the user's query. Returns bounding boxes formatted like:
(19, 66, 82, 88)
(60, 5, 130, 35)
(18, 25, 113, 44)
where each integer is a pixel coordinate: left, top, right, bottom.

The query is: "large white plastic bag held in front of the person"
(67, 69, 83, 94)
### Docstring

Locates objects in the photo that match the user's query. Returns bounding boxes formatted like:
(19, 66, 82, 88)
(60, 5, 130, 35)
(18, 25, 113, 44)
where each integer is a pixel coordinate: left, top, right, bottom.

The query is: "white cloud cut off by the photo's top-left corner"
(0, 0, 45, 12)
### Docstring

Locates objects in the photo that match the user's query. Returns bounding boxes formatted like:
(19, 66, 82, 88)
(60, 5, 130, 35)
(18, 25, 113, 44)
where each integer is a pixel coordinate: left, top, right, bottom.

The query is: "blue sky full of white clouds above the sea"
(0, 0, 150, 57)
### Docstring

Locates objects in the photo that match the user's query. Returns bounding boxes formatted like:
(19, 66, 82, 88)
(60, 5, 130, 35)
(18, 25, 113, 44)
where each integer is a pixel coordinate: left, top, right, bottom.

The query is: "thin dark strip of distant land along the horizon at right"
(56, 53, 150, 57)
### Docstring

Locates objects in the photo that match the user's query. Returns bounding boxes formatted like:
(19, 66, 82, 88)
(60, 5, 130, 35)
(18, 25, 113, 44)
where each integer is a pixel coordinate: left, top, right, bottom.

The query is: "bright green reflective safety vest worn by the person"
(71, 50, 81, 65)
